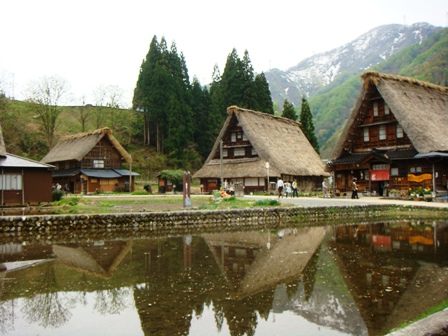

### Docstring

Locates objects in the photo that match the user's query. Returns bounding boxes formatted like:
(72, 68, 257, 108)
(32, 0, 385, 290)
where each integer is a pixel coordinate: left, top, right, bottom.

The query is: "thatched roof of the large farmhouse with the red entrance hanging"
(331, 71, 448, 158)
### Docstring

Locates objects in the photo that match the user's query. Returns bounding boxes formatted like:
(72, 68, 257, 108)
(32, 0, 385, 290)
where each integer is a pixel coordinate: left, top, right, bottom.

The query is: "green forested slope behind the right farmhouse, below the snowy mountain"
(316, 29, 448, 158)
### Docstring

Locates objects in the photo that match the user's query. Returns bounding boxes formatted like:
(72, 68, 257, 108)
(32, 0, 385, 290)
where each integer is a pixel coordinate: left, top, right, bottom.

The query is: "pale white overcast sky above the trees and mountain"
(0, 0, 448, 106)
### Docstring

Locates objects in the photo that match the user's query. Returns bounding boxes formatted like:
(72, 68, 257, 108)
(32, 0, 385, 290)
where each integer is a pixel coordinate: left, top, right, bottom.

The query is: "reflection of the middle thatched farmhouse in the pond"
(203, 227, 326, 300)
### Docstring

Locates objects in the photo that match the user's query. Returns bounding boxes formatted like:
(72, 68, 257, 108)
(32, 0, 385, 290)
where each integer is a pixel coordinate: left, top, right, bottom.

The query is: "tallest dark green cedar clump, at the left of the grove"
(133, 36, 193, 168)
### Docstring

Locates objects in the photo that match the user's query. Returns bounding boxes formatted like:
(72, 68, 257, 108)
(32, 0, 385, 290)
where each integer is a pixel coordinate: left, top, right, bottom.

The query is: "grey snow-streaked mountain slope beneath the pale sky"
(265, 23, 442, 109)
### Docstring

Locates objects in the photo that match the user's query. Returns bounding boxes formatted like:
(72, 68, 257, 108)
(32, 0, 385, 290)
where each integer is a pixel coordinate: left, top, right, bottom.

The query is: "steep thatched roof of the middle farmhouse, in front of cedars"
(193, 106, 328, 178)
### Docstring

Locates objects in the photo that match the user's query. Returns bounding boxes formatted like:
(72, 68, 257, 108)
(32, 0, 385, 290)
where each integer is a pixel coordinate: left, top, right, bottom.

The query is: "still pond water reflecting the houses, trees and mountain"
(0, 220, 448, 336)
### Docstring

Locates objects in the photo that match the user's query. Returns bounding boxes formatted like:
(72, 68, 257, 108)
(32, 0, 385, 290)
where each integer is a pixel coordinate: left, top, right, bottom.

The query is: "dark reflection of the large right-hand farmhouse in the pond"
(329, 221, 448, 335)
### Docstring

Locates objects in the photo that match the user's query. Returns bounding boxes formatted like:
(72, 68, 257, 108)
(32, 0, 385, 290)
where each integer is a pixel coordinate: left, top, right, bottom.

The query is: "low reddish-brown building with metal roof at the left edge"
(0, 122, 54, 206)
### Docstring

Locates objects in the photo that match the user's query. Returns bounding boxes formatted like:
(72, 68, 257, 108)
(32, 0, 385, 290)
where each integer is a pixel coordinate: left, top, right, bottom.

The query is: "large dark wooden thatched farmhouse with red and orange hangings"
(330, 71, 448, 196)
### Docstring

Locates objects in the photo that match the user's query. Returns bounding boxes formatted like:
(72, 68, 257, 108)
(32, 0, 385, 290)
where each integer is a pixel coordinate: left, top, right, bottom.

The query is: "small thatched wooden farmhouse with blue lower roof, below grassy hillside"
(42, 127, 139, 194)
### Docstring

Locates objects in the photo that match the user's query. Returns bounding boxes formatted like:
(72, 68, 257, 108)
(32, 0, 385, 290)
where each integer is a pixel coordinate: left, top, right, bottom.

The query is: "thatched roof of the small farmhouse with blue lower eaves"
(42, 127, 131, 163)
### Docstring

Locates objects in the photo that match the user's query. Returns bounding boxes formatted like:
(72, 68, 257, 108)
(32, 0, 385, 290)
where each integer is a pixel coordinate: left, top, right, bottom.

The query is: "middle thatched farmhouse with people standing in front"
(193, 106, 328, 194)
